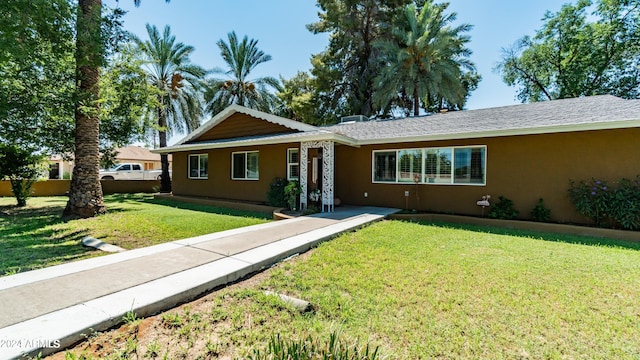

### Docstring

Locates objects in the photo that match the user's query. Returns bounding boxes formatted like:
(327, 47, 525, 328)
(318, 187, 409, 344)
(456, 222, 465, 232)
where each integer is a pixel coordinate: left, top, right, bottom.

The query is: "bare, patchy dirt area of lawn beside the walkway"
(46, 253, 309, 360)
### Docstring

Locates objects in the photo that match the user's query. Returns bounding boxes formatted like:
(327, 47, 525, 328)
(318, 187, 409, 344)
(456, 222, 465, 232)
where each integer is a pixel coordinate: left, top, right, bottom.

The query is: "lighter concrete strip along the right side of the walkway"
(0, 214, 384, 359)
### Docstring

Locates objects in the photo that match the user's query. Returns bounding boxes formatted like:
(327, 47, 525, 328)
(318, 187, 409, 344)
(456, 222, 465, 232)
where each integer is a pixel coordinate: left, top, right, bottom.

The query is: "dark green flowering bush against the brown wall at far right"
(569, 177, 640, 229)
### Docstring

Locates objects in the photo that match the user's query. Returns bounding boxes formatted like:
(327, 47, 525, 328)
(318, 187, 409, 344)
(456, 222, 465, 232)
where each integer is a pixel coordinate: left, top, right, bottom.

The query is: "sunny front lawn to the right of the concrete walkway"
(58, 221, 640, 359)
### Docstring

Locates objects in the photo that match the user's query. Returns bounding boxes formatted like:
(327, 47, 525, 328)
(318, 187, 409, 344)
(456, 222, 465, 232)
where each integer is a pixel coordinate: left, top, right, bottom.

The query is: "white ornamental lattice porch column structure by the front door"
(300, 141, 335, 212)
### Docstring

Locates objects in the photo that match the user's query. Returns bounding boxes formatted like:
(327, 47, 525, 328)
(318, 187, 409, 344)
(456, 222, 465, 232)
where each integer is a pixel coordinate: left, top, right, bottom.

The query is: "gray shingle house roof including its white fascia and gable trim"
(154, 95, 640, 153)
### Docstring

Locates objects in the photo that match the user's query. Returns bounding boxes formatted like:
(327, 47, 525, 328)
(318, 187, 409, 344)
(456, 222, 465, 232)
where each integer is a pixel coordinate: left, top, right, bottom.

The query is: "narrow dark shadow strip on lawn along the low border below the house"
(418, 222, 640, 250)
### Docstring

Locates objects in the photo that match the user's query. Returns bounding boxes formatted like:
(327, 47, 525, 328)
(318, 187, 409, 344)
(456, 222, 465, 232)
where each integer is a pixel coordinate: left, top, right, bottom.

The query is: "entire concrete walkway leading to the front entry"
(0, 207, 397, 359)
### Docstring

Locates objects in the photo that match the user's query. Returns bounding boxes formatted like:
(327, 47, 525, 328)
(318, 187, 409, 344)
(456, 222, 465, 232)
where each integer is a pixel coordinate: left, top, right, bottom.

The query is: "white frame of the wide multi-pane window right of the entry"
(371, 145, 488, 186)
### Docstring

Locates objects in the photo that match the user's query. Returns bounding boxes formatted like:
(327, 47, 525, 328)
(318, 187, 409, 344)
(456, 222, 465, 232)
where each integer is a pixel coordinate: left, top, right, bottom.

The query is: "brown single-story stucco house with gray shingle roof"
(154, 95, 640, 222)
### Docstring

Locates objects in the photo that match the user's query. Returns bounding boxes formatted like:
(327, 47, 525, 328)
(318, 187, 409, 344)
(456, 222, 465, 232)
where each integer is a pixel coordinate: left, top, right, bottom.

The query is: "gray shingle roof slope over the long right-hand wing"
(324, 95, 640, 143)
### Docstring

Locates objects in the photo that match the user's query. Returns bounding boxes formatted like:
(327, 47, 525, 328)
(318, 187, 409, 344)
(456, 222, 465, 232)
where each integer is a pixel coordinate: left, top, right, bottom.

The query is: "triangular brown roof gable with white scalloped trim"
(177, 105, 318, 145)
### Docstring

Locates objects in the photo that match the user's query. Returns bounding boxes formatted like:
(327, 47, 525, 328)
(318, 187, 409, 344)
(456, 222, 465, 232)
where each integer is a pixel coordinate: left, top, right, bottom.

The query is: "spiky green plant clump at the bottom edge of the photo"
(249, 332, 378, 360)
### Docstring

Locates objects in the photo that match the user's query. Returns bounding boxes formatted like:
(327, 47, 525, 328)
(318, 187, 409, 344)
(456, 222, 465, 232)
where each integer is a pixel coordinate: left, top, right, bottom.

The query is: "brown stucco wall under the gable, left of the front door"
(172, 143, 299, 203)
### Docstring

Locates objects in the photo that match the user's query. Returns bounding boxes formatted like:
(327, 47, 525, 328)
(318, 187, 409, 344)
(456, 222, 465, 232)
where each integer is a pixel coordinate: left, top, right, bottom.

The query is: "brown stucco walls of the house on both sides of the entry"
(173, 128, 640, 223)
